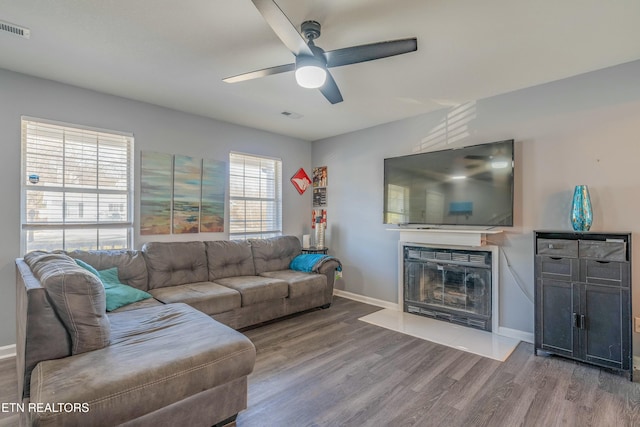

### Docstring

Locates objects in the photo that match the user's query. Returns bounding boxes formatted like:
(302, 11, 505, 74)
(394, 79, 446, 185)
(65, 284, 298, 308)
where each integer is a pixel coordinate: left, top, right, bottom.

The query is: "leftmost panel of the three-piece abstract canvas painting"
(140, 151, 173, 235)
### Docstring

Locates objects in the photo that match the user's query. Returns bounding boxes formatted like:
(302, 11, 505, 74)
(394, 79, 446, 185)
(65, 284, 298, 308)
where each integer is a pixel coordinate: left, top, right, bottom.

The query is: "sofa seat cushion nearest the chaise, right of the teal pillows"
(149, 282, 241, 316)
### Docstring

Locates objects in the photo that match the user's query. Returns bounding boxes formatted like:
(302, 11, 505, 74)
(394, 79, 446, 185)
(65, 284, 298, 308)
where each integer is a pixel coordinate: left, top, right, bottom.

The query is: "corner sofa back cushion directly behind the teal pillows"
(66, 250, 149, 291)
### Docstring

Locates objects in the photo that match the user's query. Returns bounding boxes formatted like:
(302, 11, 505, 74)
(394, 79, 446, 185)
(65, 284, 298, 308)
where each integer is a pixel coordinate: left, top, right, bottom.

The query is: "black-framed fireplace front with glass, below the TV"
(403, 246, 492, 331)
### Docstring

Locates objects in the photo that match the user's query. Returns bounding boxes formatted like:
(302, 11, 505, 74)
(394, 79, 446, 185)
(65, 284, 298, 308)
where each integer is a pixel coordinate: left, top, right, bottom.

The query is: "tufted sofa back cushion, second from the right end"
(205, 240, 256, 282)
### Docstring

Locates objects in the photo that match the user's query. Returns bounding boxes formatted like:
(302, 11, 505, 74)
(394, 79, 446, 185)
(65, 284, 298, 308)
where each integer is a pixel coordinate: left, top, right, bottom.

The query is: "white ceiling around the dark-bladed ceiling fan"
(0, 0, 640, 141)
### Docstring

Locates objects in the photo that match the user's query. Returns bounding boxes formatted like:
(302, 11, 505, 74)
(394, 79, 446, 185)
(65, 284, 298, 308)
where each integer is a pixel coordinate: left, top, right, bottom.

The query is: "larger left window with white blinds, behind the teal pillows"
(21, 117, 133, 253)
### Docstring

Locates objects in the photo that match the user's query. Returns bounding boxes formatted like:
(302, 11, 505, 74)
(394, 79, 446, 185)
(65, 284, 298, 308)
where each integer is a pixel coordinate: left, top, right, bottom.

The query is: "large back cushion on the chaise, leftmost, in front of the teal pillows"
(24, 251, 111, 354)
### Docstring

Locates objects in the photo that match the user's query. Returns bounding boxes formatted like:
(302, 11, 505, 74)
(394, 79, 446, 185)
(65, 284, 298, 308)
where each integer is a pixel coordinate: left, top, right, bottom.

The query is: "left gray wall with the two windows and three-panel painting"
(0, 69, 311, 347)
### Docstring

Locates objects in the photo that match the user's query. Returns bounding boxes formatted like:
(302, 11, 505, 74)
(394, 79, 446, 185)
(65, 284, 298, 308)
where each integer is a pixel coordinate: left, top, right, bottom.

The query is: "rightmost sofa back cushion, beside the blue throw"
(249, 236, 302, 274)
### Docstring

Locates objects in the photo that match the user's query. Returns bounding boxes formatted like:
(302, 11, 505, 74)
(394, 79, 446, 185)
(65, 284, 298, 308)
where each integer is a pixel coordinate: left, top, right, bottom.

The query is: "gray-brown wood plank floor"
(0, 298, 640, 427)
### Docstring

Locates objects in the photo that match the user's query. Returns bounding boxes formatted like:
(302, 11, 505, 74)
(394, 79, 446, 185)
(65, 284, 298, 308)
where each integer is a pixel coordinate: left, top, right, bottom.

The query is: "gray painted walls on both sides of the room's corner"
(0, 61, 640, 354)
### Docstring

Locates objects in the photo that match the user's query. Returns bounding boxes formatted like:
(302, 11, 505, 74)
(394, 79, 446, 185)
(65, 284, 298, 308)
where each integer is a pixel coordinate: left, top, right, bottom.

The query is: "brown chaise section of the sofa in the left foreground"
(16, 249, 255, 426)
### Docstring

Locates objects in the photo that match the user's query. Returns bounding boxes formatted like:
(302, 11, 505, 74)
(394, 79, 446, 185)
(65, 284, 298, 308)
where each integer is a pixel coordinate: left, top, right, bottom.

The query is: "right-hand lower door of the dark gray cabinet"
(578, 283, 629, 369)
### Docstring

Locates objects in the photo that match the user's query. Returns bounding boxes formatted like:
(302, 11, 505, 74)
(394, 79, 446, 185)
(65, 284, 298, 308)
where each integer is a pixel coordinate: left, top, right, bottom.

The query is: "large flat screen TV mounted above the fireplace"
(384, 140, 514, 227)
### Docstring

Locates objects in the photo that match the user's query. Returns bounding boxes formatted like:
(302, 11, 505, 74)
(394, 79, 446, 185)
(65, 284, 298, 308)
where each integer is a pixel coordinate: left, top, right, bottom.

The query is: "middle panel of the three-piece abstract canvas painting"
(173, 155, 202, 234)
